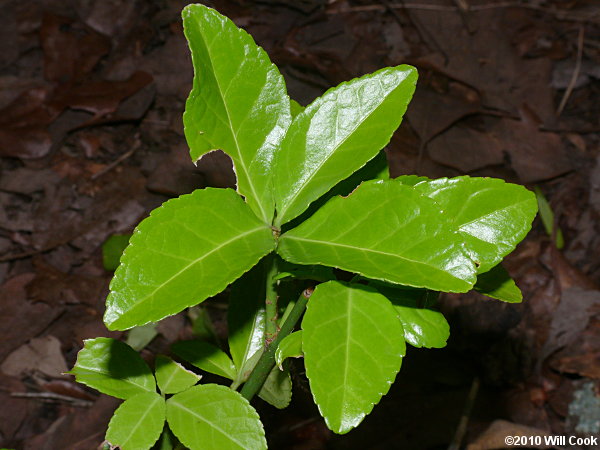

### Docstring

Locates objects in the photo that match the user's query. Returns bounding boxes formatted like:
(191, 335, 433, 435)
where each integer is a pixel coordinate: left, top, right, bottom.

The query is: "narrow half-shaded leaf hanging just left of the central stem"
(227, 264, 265, 383)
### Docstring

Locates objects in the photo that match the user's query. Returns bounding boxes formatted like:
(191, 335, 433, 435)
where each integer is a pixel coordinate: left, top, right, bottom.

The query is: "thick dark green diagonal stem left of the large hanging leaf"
(240, 288, 313, 401)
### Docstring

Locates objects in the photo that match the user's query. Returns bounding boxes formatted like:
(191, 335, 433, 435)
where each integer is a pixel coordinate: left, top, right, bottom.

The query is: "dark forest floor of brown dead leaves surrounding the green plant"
(0, 0, 600, 450)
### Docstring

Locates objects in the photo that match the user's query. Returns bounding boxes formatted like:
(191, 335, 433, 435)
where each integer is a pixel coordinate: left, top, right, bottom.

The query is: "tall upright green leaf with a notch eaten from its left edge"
(182, 4, 291, 224)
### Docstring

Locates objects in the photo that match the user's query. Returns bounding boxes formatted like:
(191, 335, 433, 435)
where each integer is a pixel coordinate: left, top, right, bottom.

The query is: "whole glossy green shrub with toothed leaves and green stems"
(72, 5, 536, 450)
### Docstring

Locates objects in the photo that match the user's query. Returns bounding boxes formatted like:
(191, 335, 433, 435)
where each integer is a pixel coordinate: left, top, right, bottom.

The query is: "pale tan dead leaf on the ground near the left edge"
(0, 336, 69, 378)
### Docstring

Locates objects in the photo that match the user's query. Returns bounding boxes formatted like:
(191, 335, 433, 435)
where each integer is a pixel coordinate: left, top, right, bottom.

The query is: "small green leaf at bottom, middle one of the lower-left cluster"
(106, 392, 165, 450)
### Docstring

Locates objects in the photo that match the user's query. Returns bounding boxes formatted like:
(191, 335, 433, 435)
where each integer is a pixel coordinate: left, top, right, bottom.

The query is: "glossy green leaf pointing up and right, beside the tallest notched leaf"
(274, 66, 417, 225)
